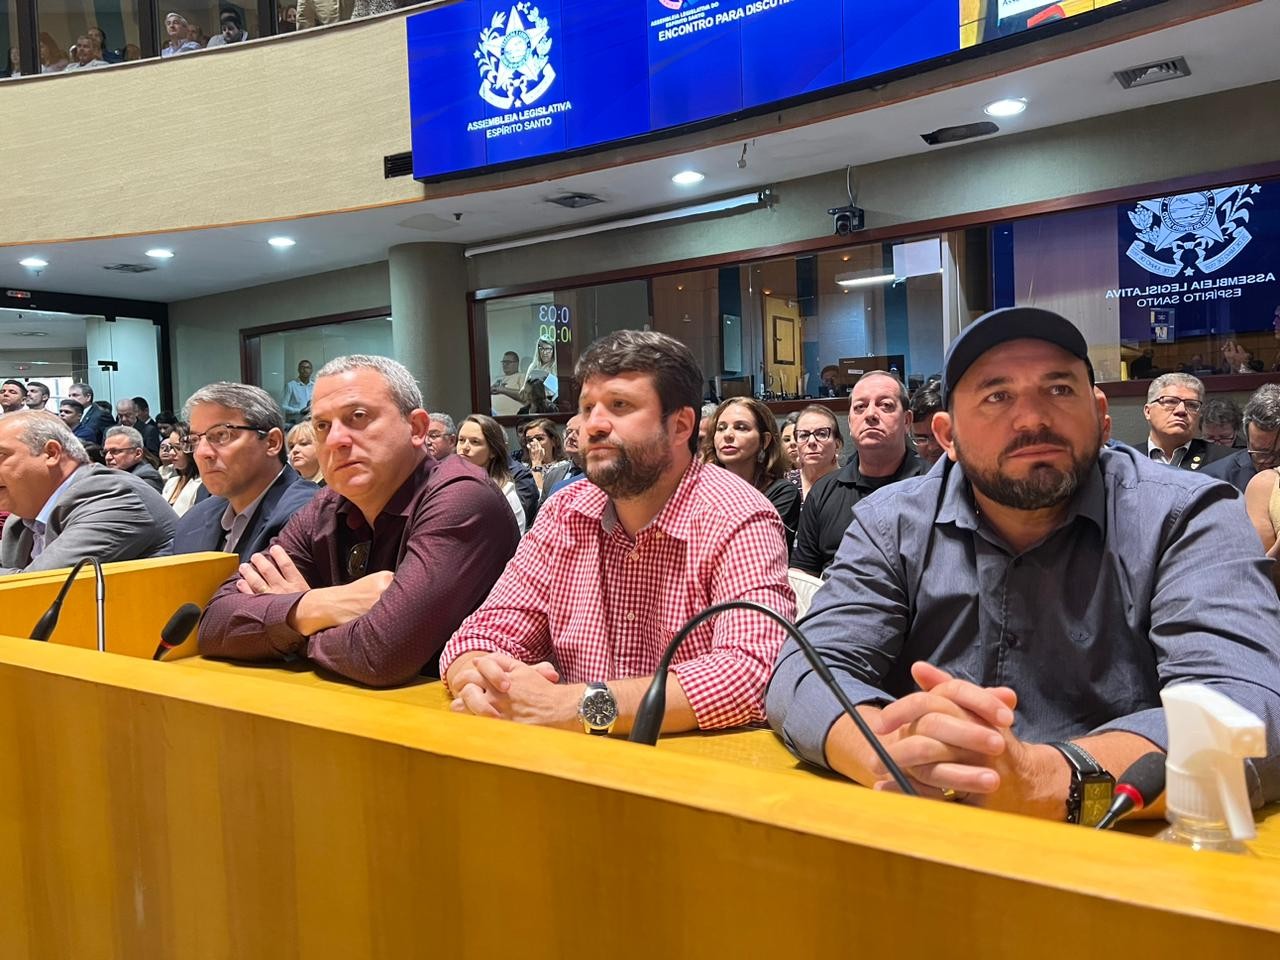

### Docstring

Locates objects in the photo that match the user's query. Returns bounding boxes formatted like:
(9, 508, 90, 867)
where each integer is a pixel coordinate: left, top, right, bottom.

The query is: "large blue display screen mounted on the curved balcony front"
(407, 0, 1156, 180)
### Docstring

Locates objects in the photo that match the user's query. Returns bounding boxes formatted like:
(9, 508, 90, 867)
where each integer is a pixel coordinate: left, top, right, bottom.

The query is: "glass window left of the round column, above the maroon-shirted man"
(244, 316, 393, 424)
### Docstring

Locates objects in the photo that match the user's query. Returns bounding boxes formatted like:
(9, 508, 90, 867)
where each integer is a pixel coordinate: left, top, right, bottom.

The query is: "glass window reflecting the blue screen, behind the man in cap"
(992, 180, 1280, 380)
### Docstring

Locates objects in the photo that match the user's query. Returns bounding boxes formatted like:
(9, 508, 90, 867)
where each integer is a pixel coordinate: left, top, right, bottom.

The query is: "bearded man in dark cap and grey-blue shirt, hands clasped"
(767, 307, 1280, 823)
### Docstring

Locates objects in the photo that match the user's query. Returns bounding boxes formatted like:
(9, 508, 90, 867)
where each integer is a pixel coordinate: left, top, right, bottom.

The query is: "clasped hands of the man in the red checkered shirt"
(449, 653, 581, 728)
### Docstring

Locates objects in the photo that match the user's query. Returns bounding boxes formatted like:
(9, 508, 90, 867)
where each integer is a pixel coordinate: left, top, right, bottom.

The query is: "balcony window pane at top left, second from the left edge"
(37, 0, 142, 73)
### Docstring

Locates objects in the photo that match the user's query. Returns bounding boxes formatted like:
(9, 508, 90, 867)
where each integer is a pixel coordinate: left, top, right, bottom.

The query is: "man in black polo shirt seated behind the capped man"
(791, 370, 928, 576)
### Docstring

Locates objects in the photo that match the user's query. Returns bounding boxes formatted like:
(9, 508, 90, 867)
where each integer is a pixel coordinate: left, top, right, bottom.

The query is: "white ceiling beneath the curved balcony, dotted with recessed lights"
(0, 3, 1280, 302)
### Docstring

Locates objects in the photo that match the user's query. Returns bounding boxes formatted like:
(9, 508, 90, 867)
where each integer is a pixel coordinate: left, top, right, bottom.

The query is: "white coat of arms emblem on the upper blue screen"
(475, 0, 556, 110)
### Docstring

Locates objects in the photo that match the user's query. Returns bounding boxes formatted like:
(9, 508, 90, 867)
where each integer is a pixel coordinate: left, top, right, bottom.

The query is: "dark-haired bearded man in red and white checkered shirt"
(440, 330, 795, 733)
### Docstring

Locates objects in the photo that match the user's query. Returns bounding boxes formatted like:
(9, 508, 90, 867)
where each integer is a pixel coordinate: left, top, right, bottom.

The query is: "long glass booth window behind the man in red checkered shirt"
(477, 237, 950, 416)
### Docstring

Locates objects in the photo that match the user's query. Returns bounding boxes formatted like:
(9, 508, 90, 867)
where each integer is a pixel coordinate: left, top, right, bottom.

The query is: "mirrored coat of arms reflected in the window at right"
(1126, 183, 1262, 276)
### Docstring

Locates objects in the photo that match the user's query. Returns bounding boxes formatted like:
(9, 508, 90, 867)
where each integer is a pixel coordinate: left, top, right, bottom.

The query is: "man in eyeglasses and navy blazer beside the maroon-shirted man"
(173, 383, 319, 561)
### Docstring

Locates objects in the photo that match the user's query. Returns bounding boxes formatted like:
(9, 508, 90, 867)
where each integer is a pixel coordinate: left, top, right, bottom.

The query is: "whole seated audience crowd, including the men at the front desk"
(0, 312, 1280, 819)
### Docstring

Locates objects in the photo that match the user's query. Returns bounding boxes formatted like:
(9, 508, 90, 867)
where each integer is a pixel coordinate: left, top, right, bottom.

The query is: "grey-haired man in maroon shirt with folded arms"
(200, 355, 520, 686)
